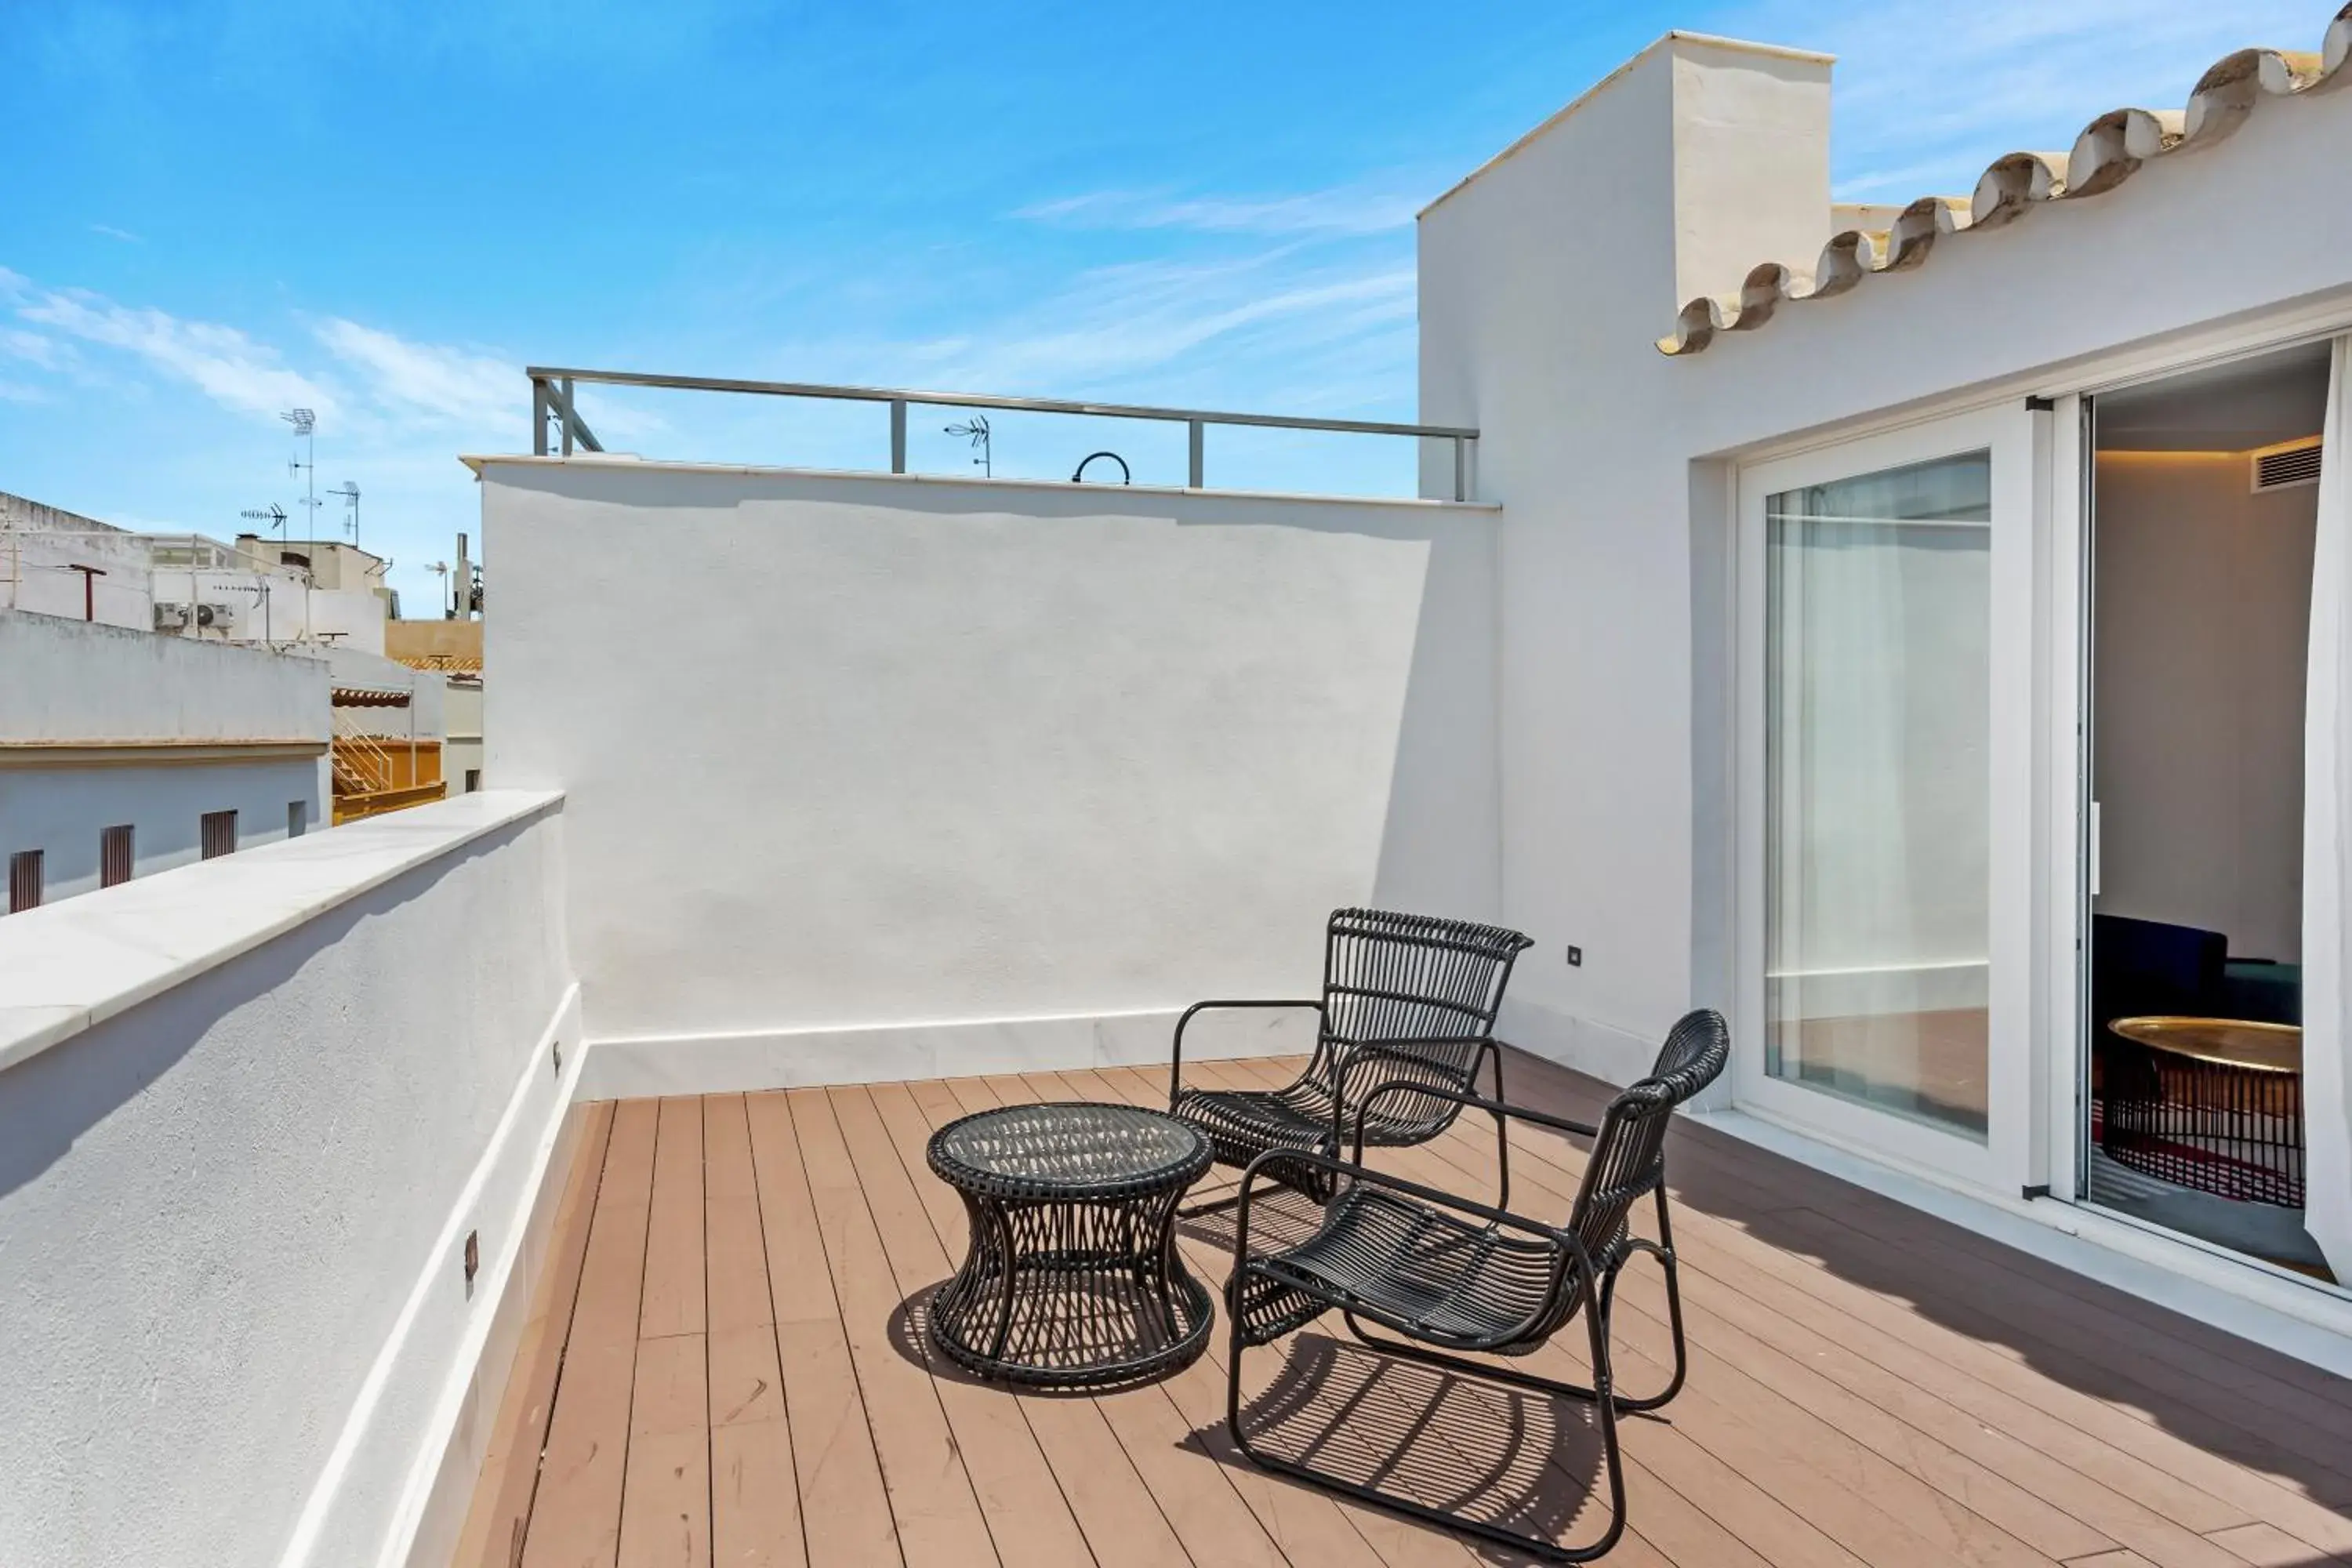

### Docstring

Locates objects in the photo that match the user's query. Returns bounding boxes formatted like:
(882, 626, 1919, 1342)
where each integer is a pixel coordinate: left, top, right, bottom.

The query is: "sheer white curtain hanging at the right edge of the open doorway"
(2303, 336, 2352, 1283)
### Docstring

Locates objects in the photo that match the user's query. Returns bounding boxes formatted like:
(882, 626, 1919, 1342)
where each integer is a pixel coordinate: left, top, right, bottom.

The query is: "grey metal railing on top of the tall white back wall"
(527, 365, 1477, 501)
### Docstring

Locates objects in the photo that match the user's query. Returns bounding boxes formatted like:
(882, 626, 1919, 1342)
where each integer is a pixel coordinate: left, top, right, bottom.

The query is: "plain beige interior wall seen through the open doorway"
(2093, 452, 2319, 964)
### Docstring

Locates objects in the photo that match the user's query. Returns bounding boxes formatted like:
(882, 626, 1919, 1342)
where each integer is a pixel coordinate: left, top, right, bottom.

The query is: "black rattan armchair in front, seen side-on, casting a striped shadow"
(1225, 1011, 1731, 1563)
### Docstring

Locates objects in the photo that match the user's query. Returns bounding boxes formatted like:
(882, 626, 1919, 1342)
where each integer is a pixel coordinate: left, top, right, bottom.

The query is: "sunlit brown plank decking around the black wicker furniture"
(459, 1055, 2352, 1568)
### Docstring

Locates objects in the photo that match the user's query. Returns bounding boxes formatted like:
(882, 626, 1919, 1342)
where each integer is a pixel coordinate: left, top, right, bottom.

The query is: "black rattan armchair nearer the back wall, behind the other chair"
(1169, 909, 1531, 1213)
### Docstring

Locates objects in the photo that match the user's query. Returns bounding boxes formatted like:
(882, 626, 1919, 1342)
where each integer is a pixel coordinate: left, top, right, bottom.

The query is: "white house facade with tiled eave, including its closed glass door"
(1421, 27, 2352, 1312)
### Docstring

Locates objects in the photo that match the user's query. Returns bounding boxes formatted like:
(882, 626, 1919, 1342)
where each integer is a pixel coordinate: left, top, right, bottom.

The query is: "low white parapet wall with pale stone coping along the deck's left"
(0, 789, 579, 1568)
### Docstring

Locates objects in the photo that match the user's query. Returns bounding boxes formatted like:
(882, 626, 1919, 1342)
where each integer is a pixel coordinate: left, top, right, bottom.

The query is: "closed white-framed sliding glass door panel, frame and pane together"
(1736, 412, 2032, 1180)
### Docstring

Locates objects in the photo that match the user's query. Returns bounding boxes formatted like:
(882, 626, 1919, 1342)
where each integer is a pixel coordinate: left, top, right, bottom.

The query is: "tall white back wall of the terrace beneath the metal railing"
(482, 459, 1496, 1093)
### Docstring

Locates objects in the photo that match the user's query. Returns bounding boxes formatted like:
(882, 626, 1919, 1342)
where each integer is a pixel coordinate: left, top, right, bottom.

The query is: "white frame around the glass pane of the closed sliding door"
(1731, 400, 2051, 1192)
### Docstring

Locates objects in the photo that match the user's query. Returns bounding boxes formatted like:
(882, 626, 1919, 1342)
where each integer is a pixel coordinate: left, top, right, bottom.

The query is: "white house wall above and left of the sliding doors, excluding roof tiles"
(1421, 27, 2352, 1081)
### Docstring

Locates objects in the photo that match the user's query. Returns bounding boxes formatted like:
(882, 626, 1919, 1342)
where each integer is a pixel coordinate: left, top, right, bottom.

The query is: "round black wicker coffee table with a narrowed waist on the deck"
(929, 1105, 1214, 1387)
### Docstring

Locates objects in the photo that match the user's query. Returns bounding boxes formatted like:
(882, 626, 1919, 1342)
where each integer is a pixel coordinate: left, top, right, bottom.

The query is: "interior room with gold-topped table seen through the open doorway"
(2086, 343, 2328, 1276)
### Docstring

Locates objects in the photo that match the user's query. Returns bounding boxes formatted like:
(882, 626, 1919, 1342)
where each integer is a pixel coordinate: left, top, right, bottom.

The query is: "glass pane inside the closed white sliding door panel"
(1762, 452, 1992, 1140)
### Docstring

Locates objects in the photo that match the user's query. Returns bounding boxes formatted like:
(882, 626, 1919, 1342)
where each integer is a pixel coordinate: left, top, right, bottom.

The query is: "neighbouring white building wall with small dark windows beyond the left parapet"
(0, 612, 327, 902)
